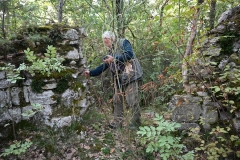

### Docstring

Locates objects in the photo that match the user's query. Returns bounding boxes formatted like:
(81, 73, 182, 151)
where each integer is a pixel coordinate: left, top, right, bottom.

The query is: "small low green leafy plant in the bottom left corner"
(0, 140, 32, 157)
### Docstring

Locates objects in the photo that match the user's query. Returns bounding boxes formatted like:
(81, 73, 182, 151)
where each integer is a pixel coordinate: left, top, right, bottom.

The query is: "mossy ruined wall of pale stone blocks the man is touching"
(0, 26, 93, 137)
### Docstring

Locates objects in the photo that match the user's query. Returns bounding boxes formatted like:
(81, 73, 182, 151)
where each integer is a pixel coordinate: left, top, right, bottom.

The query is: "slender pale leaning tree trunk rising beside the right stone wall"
(182, 0, 204, 92)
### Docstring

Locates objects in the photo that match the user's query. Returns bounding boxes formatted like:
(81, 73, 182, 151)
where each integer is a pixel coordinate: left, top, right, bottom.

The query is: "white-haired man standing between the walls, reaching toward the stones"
(84, 31, 143, 129)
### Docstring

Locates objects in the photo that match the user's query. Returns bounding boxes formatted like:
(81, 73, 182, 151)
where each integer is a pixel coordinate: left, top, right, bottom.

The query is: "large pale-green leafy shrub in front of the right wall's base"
(137, 114, 193, 160)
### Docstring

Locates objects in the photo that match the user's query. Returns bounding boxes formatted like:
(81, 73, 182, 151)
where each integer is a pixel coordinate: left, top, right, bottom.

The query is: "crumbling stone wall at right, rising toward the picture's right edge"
(169, 6, 240, 131)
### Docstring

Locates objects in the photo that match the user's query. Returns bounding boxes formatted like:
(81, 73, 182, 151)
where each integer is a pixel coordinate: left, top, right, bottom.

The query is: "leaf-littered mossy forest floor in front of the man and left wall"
(0, 104, 160, 160)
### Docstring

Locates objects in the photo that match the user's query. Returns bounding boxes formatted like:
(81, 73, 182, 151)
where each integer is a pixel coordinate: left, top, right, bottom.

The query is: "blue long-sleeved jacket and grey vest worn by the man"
(90, 39, 143, 83)
